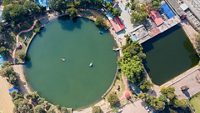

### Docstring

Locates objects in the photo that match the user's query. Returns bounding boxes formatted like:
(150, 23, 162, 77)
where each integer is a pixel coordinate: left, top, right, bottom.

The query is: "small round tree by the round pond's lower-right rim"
(107, 93, 119, 107)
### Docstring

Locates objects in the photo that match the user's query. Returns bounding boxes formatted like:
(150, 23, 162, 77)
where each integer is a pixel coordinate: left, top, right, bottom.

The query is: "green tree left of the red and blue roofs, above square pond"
(131, 4, 148, 23)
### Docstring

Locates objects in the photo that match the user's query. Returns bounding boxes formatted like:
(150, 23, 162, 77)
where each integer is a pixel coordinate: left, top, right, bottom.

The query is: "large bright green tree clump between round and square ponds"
(119, 42, 145, 82)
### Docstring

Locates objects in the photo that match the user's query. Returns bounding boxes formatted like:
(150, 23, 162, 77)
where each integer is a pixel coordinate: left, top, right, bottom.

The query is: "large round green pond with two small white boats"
(24, 18, 117, 108)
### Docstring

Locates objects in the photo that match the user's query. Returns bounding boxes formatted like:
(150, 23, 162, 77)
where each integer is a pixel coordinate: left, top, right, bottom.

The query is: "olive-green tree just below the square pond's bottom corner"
(160, 87, 176, 101)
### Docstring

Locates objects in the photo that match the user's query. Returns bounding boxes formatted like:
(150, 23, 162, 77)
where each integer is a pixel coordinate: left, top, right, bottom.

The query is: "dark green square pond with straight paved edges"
(142, 25, 199, 85)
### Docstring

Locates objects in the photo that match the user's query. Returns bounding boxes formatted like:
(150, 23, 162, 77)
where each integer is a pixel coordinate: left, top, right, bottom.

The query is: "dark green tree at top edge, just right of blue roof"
(49, 0, 67, 13)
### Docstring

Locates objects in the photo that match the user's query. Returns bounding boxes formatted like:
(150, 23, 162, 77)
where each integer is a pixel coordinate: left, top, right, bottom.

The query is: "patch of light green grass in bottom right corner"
(190, 93, 200, 113)
